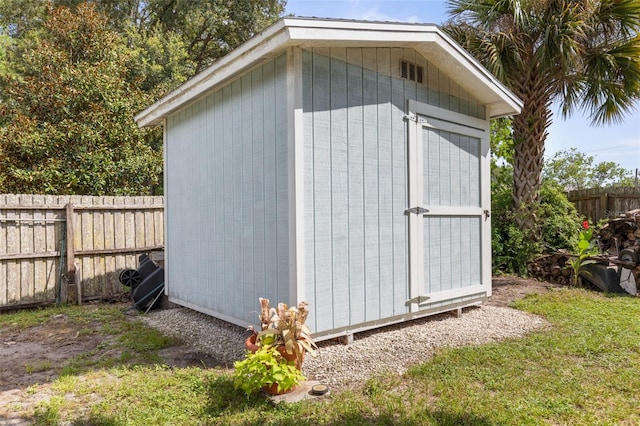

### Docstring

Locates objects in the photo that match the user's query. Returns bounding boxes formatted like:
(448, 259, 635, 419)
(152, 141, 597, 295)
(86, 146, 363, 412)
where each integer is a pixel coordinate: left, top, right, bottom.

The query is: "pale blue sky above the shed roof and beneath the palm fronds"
(286, 0, 640, 175)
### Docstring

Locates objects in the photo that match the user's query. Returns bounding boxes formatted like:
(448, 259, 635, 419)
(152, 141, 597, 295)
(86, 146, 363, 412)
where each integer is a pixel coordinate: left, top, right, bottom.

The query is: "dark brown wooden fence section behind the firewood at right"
(568, 187, 640, 222)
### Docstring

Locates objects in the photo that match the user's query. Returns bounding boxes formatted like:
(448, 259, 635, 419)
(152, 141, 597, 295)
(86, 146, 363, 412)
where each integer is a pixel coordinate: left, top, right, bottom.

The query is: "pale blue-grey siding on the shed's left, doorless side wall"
(165, 55, 289, 322)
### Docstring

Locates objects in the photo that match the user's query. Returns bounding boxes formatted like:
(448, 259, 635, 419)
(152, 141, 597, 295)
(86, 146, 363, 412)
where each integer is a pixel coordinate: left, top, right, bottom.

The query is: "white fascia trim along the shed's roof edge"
(134, 17, 522, 127)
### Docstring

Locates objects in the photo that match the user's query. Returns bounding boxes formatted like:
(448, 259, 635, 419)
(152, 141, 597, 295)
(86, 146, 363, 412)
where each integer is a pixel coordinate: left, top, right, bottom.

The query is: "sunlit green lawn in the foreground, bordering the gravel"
(5, 289, 640, 425)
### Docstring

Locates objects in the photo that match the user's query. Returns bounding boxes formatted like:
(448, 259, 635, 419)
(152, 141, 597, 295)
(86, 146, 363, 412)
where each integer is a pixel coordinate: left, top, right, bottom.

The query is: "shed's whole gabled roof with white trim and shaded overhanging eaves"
(135, 17, 522, 127)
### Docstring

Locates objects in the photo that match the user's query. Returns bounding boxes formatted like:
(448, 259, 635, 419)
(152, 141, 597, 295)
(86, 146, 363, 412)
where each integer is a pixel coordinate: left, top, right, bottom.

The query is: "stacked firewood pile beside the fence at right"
(527, 209, 640, 285)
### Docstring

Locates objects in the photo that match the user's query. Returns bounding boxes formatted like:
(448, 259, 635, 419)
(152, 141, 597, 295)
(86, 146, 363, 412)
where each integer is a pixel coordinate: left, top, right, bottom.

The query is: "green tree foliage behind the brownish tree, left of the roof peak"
(0, 0, 286, 82)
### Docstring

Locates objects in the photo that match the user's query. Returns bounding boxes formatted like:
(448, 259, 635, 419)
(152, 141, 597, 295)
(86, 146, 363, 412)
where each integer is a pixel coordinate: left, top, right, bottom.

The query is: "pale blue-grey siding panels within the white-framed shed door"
(422, 128, 482, 293)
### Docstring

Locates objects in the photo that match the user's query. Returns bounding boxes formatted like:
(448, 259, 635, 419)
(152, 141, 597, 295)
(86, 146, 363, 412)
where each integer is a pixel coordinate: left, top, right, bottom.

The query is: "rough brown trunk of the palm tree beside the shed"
(513, 76, 552, 242)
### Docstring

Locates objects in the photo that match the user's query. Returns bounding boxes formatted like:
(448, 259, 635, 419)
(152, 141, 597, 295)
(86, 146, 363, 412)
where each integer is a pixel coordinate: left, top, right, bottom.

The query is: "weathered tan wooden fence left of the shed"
(0, 195, 164, 310)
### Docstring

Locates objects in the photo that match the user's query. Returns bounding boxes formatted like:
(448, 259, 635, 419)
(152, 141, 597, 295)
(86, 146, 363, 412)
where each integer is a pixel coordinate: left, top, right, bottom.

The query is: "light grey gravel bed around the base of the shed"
(142, 305, 547, 389)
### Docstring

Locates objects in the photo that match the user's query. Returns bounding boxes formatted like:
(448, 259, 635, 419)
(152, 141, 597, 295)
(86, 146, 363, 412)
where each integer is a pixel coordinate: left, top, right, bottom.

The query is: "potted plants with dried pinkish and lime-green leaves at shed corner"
(234, 298, 317, 394)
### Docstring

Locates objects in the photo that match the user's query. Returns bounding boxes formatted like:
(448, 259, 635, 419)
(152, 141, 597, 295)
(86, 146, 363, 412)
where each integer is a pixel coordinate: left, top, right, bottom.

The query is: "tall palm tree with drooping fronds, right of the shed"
(445, 0, 640, 240)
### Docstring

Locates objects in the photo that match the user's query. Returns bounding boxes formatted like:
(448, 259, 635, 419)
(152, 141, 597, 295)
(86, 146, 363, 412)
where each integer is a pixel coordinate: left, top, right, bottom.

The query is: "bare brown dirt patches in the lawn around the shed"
(0, 277, 558, 425)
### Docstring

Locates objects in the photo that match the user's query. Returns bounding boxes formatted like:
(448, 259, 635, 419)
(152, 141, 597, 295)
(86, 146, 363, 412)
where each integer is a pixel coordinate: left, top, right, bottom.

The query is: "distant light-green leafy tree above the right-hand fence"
(542, 148, 633, 191)
